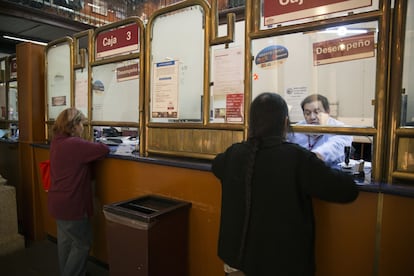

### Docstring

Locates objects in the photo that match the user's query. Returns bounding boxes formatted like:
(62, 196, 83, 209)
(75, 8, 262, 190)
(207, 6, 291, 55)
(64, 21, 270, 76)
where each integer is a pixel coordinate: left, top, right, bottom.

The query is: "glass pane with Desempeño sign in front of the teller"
(252, 22, 378, 127)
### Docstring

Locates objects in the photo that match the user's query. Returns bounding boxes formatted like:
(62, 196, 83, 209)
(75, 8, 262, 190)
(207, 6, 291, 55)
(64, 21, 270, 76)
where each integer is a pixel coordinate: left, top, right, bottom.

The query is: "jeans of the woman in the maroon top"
(56, 218, 92, 276)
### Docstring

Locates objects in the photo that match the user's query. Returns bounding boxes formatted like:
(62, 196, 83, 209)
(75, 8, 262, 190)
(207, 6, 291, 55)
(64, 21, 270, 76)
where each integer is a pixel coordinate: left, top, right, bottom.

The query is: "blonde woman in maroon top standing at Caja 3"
(48, 108, 109, 276)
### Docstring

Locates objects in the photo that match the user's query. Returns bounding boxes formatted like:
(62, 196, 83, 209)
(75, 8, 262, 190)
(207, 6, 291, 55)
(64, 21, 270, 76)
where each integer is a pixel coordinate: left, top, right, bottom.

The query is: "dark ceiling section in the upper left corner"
(0, 0, 93, 54)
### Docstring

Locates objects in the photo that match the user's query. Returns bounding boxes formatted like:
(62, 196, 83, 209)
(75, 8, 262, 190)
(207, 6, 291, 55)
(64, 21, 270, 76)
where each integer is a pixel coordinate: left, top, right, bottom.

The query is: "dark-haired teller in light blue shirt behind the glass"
(288, 94, 352, 167)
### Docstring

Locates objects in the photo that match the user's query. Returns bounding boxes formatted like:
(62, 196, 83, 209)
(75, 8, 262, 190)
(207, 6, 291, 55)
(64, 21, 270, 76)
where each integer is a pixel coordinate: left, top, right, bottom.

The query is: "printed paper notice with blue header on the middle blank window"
(151, 60, 178, 118)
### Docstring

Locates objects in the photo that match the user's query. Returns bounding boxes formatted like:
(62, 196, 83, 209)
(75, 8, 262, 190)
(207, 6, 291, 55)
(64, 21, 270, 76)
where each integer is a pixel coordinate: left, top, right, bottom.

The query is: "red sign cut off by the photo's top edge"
(263, 0, 372, 26)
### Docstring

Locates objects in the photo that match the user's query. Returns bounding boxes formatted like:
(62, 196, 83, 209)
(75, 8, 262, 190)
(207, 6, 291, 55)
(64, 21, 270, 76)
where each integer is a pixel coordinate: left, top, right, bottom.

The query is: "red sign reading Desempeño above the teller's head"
(313, 32, 375, 65)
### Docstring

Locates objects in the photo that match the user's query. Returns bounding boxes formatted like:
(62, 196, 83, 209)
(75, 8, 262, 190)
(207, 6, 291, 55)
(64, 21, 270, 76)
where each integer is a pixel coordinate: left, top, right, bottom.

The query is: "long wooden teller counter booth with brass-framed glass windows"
(0, 0, 414, 276)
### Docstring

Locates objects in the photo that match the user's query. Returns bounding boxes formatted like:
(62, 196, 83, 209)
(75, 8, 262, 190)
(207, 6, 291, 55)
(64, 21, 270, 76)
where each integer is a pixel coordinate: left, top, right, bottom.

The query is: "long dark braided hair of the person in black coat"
(239, 92, 290, 263)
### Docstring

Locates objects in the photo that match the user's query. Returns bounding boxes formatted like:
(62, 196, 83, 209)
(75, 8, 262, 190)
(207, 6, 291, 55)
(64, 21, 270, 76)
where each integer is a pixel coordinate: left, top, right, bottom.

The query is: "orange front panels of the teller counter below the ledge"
(34, 147, 414, 276)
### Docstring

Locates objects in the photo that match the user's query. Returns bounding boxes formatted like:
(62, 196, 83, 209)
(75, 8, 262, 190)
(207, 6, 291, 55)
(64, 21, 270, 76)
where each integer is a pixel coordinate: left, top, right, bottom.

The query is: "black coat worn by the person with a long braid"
(212, 137, 358, 276)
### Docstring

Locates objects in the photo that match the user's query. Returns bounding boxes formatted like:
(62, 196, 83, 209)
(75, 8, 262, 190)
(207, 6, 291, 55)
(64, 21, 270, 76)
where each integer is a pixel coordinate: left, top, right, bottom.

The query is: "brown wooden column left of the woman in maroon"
(16, 43, 46, 240)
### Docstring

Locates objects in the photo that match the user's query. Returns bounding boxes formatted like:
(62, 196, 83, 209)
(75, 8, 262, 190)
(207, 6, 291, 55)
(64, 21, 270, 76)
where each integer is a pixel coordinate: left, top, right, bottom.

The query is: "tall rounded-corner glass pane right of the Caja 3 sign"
(149, 5, 205, 122)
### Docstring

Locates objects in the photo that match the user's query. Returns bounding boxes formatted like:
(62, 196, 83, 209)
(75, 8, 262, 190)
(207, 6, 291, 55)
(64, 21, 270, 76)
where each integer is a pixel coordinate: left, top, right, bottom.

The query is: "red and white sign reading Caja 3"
(96, 24, 139, 58)
